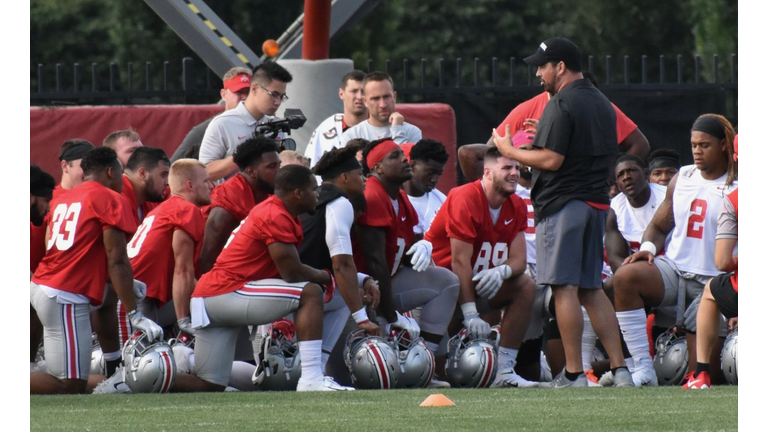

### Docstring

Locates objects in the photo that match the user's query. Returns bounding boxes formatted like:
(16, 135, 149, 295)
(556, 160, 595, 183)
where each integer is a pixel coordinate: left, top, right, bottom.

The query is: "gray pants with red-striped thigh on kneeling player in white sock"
(195, 279, 307, 386)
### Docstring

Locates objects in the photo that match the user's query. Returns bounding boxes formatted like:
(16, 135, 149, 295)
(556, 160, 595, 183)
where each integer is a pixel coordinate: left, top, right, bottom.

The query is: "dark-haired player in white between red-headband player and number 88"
(401, 139, 448, 234)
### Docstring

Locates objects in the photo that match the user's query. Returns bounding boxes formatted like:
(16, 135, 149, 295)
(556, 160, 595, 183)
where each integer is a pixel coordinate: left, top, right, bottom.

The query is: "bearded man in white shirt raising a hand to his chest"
(341, 72, 421, 145)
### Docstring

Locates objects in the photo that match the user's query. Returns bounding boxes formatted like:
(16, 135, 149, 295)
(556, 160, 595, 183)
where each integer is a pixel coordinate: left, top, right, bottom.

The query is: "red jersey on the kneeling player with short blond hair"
(128, 196, 204, 307)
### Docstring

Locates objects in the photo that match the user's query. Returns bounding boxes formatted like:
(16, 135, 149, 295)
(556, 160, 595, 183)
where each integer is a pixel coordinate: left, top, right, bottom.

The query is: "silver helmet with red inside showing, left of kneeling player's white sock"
(253, 318, 301, 390)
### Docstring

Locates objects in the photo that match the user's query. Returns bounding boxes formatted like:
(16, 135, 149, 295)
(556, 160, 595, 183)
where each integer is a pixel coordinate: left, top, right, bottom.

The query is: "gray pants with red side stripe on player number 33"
(29, 282, 93, 380)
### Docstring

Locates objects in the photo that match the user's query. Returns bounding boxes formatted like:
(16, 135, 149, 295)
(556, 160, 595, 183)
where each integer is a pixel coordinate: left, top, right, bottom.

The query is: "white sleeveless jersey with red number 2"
(666, 165, 738, 276)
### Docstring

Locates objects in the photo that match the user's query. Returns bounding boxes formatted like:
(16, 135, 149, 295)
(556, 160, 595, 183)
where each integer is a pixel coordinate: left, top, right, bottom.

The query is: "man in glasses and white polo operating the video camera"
(200, 62, 293, 184)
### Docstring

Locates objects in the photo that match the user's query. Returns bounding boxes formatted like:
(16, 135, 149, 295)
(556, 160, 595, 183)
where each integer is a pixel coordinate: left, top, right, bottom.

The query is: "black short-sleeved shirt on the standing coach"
(531, 79, 618, 223)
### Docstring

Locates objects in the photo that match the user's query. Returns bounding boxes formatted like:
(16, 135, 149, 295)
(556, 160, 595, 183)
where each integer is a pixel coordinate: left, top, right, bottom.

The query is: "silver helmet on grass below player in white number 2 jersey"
(653, 326, 688, 386)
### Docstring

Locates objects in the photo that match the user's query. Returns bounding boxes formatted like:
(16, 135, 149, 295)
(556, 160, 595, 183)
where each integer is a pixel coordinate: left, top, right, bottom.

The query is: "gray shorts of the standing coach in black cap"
(536, 200, 608, 289)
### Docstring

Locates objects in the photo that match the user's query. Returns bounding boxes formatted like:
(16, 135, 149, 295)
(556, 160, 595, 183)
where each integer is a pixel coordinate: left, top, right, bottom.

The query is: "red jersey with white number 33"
(32, 181, 136, 305)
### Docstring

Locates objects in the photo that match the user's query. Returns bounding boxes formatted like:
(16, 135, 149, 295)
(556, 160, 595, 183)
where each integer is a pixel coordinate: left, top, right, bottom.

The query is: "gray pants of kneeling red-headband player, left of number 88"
(392, 266, 459, 334)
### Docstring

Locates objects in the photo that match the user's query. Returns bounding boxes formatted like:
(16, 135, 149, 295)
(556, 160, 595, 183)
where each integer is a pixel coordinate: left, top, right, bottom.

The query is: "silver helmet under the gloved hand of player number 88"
(445, 327, 499, 388)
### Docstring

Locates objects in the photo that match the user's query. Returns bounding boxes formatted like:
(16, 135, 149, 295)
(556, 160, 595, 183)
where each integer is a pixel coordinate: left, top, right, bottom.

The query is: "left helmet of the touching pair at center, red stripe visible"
(344, 330, 400, 389)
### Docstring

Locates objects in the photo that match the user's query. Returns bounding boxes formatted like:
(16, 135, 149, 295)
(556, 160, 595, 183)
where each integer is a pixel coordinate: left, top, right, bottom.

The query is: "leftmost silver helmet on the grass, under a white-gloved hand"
(123, 331, 176, 393)
